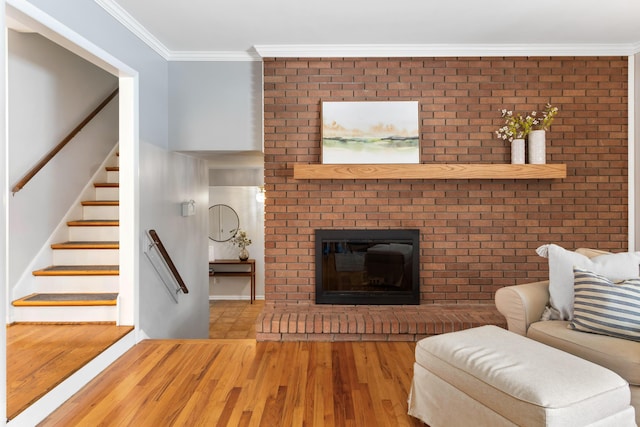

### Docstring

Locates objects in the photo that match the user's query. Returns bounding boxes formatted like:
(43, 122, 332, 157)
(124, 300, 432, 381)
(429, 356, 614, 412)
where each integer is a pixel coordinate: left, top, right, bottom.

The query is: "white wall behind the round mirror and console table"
(209, 186, 264, 300)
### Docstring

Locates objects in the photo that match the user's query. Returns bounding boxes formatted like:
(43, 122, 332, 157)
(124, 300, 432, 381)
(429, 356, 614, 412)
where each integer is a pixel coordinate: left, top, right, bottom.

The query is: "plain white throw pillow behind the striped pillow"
(536, 244, 640, 320)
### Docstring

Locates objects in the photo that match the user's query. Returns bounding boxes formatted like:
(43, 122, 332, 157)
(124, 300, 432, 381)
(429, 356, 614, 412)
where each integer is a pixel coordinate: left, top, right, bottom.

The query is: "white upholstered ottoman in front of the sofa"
(409, 326, 636, 427)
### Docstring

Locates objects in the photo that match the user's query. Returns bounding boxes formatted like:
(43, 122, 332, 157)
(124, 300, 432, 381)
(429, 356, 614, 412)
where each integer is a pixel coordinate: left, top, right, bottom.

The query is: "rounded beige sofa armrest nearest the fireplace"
(495, 280, 549, 335)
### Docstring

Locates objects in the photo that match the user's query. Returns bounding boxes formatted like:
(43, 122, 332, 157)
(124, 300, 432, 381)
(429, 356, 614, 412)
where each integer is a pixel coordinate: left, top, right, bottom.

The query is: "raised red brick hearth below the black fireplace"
(256, 303, 506, 341)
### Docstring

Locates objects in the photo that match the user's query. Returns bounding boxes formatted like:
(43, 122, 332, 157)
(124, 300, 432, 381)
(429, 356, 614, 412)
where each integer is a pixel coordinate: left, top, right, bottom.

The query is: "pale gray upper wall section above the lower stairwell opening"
(169, 62, 262, 151)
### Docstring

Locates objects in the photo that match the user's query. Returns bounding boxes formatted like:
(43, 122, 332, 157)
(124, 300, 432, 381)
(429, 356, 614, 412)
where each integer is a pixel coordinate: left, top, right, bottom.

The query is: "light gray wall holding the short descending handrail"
(140, 144, 209, 338)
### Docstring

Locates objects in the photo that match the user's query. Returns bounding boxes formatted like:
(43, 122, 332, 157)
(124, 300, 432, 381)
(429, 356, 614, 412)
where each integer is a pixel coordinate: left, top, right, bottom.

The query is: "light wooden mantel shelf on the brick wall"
(293, 163, 567, 179)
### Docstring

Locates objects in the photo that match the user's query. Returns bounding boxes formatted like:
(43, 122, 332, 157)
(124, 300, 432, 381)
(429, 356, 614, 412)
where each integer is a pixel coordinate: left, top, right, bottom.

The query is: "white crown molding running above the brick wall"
(255, 43, 640, 58)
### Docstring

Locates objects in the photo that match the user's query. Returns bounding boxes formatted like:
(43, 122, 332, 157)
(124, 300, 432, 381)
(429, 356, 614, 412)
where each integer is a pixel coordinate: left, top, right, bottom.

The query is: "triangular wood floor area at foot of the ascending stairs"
(7, 324, 133, 419)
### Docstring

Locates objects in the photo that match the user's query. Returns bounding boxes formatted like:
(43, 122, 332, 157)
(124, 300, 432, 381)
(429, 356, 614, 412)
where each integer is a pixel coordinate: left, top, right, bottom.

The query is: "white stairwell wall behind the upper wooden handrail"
(7, 31, 118, 287)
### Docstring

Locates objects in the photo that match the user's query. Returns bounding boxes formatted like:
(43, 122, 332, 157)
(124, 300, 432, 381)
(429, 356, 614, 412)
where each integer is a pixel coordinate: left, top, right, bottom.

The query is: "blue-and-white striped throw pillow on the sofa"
(569, 267, 640, 341)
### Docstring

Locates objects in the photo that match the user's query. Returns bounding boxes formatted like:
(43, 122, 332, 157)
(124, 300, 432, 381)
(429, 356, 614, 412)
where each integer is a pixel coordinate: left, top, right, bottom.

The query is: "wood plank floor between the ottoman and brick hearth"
(41, 340, 424, 427)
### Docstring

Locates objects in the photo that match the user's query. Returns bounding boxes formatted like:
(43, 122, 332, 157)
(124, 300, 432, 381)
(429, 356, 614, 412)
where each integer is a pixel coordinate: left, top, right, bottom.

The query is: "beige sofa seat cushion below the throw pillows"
(527, 320, 640, 386)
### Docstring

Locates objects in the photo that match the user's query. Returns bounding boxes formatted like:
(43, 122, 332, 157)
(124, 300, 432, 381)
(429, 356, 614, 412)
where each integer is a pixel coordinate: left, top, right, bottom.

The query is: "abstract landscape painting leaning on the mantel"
(322, 101, 420, 164)
